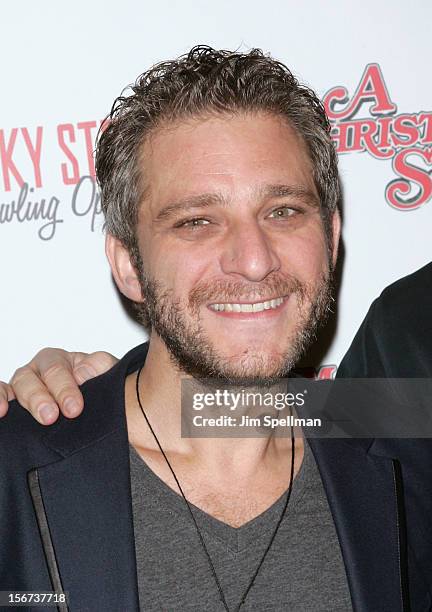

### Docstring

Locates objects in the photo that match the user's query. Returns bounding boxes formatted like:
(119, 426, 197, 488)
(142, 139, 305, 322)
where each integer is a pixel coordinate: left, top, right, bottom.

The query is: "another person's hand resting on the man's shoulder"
(0, 348, 117, 425)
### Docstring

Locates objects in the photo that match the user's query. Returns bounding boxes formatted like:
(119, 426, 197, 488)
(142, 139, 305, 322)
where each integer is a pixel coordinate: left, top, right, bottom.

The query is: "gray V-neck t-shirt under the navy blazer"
(130, 443, 352, 612)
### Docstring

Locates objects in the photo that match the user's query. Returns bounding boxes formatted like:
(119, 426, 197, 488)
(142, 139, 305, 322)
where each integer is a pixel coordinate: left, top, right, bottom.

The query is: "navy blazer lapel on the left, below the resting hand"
(34, 433, 139, 610)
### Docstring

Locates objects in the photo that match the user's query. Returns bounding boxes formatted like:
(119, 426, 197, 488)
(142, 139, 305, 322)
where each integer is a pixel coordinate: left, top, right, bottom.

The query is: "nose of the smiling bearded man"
(221, 220, 280, 282)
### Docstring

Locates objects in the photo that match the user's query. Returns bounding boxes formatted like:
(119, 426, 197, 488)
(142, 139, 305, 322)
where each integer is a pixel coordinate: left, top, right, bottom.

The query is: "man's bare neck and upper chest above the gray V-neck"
(125, 340, 304, 527)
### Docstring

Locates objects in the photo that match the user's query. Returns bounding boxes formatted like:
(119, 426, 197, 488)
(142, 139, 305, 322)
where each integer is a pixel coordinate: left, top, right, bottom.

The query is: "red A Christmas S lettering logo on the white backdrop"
(323, 64, 432, 210)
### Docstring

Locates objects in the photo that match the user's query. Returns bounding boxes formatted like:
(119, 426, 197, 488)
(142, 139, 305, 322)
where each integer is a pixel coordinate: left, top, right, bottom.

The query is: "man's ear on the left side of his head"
(105, 234, 143, 302)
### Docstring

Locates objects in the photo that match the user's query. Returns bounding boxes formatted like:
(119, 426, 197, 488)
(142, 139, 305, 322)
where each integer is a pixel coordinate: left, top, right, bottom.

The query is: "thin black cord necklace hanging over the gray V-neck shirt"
(136, 365, 295, 612)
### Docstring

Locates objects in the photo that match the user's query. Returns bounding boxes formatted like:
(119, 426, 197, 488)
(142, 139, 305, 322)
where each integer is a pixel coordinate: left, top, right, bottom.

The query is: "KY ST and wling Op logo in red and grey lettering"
(0, 121, 102, 241)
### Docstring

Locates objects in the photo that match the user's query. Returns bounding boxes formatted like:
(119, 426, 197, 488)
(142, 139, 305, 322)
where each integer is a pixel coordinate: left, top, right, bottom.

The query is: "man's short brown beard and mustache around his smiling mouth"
(138, 266, 333, 387)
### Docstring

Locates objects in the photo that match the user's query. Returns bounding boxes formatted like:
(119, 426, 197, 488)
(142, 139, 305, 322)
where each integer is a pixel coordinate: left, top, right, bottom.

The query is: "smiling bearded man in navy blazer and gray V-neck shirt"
(0, 47, 422, 612)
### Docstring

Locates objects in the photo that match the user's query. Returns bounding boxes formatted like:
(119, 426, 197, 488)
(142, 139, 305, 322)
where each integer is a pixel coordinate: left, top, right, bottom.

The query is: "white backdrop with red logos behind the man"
(0, 0, 432, 379)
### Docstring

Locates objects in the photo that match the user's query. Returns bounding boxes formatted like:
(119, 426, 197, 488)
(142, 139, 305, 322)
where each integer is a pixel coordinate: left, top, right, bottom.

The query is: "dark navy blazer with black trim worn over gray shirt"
(0, 258, 432, 612)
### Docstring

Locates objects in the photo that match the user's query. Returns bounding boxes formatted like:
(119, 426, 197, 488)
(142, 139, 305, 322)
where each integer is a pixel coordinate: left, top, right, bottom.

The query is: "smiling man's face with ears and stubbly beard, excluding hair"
(115, 110, 339, 388)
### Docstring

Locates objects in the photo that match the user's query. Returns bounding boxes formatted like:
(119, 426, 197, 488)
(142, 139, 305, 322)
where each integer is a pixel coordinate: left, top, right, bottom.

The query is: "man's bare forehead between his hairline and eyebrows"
(141, 114, 319, 212)
